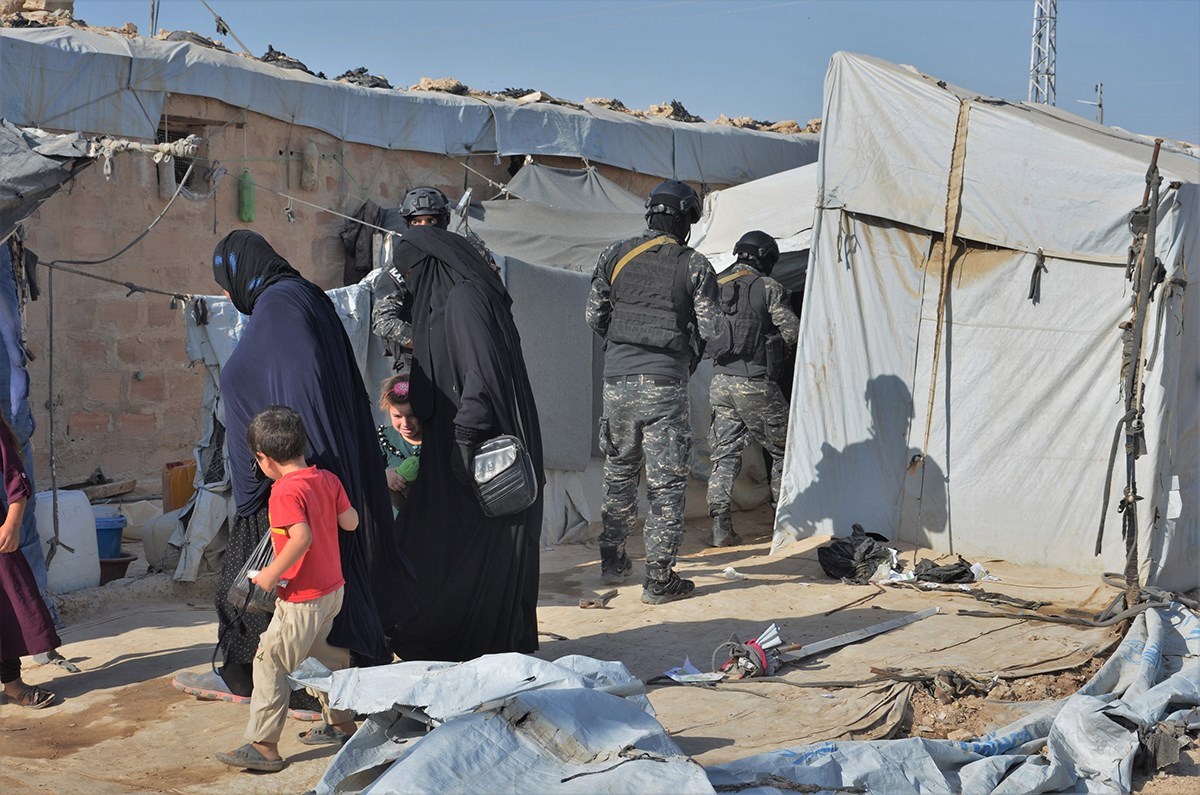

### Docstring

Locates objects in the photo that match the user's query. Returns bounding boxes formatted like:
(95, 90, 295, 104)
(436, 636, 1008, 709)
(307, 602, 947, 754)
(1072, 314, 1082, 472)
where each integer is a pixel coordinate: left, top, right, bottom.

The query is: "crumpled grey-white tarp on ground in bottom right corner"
(708, 605, 1200, 795)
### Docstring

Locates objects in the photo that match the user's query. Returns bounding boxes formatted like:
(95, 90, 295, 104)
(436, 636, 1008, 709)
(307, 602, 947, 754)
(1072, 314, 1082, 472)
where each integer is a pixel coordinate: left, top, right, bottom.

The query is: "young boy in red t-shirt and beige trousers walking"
(216, 406, 359, 772)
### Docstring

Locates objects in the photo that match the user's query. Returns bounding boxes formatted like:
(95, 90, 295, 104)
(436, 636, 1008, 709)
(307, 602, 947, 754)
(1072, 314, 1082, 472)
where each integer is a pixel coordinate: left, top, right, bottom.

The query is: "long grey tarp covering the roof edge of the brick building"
(0, 28, 817, 184)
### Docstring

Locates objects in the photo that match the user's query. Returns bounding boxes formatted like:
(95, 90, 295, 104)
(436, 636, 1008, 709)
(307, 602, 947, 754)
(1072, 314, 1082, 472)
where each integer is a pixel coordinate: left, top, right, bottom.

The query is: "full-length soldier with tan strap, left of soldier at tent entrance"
(587, 180, 720, 604)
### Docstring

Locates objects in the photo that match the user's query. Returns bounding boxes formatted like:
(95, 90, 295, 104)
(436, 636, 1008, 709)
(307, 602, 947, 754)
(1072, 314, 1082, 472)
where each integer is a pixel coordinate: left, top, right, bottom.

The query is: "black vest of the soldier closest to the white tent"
(708, 271, 784, 381)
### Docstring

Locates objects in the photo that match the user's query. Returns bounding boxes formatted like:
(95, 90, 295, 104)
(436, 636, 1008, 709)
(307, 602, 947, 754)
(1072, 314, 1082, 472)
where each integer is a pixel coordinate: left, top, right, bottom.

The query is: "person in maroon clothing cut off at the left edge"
(0, 418, 61, 710)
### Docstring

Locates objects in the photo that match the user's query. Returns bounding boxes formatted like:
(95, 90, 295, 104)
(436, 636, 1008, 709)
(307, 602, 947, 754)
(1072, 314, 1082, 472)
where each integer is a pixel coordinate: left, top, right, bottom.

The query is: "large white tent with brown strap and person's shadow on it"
(774, 53, 1200, 588)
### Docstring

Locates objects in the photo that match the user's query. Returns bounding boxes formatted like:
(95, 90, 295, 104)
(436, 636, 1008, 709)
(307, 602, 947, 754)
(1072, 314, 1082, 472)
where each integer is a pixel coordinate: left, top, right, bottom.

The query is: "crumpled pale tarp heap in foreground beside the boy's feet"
(292, 653, 713, 794)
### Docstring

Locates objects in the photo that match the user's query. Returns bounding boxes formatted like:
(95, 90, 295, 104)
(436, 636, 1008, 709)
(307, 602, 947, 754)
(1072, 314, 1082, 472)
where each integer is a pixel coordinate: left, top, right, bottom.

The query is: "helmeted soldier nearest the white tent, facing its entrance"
(706, 231, 800, 546)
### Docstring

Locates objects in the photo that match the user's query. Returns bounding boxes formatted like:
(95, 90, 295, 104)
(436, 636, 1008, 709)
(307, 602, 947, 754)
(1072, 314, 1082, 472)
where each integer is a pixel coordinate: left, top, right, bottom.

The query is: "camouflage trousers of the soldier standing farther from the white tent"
(600, 376, 691, 580)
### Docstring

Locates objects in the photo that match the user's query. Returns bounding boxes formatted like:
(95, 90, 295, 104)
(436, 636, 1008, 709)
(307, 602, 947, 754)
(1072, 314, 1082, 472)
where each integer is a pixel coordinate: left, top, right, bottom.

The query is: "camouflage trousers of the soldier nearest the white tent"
(708, 373, 787, 516)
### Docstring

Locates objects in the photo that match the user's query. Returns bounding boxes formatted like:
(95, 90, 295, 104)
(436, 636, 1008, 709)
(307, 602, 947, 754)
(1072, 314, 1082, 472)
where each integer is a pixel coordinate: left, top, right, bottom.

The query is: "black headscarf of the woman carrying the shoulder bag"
(392, 226, 512, 420)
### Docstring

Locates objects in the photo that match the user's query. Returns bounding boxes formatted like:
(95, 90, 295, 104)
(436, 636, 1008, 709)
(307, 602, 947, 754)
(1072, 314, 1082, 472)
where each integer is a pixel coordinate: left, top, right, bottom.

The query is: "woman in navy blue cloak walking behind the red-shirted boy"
(212, 229, 393, 695)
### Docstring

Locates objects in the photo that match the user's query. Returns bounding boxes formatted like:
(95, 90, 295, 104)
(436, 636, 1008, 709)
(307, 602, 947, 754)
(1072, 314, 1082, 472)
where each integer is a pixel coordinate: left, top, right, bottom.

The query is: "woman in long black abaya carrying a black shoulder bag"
(384, 227, 544, 660)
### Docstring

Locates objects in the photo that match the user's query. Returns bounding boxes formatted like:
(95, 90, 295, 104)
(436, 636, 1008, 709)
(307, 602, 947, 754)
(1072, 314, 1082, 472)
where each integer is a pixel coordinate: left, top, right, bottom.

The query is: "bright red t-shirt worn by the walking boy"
(266, 466, 350, 602)
